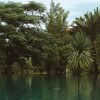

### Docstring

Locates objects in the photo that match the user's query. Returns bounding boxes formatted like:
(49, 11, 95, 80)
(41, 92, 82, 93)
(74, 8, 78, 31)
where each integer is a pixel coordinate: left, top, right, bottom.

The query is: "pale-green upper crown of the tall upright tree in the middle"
(46, 0, 69, 35)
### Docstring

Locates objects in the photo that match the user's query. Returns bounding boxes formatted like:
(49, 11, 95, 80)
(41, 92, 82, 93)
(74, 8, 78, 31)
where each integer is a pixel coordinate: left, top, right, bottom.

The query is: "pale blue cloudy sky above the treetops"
(0, 0, 100, 24)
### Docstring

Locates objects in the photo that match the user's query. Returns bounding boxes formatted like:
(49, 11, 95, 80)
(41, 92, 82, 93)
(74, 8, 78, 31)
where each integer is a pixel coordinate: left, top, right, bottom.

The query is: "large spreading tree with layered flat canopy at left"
(0, 2, 45, 73)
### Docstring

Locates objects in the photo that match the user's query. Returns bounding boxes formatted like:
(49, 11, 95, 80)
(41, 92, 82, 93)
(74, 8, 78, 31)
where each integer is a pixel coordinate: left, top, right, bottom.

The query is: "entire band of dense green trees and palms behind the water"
(0, 1, 100, 74)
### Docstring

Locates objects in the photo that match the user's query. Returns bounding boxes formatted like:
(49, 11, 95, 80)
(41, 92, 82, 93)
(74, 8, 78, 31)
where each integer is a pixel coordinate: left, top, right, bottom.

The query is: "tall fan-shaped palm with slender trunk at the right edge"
(74, 7, 100, 73)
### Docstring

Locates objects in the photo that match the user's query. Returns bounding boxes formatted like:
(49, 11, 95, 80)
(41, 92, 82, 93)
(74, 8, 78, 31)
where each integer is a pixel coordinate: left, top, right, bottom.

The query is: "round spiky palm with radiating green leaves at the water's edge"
(68, 33, 93, 73)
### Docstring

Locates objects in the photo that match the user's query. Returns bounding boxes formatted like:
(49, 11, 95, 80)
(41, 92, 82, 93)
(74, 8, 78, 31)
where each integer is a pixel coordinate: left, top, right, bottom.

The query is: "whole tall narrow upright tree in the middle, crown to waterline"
(46, 0, 69, 74)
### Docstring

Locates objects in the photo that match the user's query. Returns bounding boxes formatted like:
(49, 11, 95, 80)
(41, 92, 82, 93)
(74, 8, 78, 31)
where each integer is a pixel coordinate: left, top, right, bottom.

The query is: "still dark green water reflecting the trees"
(0, 75, 100, 100)
